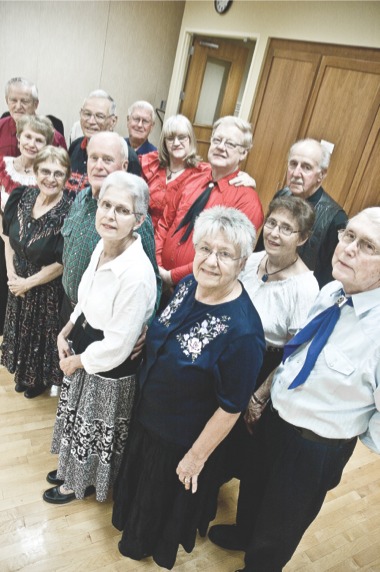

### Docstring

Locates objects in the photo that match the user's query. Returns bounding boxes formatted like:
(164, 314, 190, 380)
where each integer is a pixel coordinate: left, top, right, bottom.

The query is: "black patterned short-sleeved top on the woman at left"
(3, 187, 71, 270)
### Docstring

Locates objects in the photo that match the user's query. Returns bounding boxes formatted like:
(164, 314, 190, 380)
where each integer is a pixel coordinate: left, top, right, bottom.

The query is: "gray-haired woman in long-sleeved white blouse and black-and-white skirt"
(43, 171, 156, 504)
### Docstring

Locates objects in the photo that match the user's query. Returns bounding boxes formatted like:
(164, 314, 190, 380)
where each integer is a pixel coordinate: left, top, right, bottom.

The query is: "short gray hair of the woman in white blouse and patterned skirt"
(99, 171, 149, 222)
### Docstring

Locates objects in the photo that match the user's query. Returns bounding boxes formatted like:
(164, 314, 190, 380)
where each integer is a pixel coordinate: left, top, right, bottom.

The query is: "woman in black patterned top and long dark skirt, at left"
(1, 145, 71, 398)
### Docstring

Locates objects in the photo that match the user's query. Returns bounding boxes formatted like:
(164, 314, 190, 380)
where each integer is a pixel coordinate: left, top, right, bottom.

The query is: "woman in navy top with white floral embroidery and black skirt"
(113, 207, 264, 569)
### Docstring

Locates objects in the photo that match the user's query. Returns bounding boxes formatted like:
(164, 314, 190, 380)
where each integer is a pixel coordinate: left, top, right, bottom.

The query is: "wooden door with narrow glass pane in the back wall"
(180, 37, 249, 160)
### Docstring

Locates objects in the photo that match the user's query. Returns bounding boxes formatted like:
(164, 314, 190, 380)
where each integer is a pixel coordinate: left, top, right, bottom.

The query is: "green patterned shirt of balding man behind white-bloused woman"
(61, 187, 162, 311)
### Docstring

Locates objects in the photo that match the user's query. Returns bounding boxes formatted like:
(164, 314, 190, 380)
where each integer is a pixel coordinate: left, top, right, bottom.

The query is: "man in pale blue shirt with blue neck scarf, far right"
(209, 207, 380, 572)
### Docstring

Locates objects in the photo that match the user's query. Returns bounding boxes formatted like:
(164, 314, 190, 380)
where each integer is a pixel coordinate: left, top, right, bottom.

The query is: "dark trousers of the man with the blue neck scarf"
(237, 407, 357, 572)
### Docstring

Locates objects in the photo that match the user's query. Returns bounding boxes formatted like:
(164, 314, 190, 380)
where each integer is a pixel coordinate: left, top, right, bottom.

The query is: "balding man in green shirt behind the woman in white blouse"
(62, 131, 161, 323)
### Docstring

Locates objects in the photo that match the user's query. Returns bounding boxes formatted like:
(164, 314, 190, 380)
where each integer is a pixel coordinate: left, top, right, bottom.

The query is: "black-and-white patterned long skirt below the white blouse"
(51, 369, 136, 501)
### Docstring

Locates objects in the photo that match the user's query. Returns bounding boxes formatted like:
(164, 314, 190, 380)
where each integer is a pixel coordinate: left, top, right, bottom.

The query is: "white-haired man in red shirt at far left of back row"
(0, 77, 66, 157)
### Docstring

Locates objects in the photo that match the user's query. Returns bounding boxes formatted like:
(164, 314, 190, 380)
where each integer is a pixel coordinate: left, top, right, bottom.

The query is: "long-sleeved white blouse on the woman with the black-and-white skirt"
(70, 234, 156, 373)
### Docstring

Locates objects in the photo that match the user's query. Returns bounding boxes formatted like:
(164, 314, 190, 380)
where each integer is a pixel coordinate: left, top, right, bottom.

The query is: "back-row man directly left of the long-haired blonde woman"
(126, 101, 157, 155)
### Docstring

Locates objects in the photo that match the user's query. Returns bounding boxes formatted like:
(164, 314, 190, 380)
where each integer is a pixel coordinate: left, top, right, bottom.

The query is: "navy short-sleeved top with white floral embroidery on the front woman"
(137, 275, 265, 447)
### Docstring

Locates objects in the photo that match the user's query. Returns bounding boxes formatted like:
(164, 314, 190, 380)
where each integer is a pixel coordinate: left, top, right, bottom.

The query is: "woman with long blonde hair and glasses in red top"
(140, 115, 210, 228)
